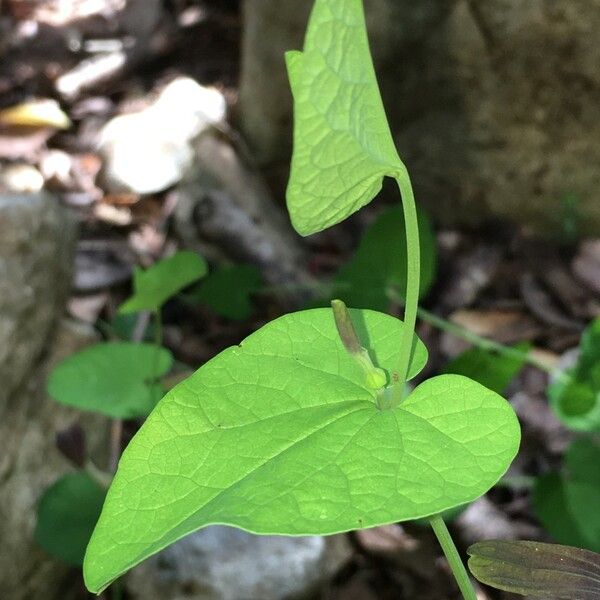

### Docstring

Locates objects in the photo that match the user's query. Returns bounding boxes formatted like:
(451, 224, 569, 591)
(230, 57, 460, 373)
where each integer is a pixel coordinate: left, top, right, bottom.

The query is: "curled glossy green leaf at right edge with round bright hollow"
(548, 318, 600, 431)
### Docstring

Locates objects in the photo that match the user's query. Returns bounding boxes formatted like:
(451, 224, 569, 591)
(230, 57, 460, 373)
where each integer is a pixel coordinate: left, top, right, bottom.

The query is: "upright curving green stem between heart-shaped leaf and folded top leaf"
(394, 170, 421, 398)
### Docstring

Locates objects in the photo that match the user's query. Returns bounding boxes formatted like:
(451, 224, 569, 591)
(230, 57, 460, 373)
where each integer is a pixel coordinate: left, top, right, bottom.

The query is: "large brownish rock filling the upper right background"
(398, 0, 600, 233)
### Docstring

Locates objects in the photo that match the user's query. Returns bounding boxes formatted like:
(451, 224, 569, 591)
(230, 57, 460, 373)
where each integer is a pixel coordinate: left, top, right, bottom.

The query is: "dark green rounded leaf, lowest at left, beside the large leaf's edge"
(34, 473, 106, 567)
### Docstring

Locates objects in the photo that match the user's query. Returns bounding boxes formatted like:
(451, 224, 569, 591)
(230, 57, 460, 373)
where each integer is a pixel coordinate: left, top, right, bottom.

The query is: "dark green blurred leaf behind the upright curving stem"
(332, 205, 437, 311)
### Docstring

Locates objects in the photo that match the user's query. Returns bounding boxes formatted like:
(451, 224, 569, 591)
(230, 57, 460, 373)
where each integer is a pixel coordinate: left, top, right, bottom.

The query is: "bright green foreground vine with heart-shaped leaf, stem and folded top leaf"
(84, 0, 520, 600)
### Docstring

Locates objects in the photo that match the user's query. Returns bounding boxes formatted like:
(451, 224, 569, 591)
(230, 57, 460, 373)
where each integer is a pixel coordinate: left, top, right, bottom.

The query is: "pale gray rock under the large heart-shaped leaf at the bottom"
(127, 526, 350, 600)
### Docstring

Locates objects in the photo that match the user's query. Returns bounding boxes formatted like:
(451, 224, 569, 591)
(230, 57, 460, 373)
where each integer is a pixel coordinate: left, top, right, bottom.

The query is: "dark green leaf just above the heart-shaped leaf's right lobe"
(444, 342, 531, 394)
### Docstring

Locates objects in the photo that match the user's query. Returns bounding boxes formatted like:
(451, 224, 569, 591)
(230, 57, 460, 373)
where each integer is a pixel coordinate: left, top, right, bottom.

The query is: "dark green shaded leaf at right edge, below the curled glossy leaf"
(533, 439, 600, 552)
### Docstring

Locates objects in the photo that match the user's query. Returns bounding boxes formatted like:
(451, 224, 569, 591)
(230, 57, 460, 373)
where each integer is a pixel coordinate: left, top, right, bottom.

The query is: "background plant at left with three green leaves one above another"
(35, 252, 207, 566)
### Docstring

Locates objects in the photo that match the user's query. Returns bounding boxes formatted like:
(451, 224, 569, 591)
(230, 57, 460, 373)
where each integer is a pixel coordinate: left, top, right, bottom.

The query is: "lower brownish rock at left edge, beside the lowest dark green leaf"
(0, 320, 108, 600)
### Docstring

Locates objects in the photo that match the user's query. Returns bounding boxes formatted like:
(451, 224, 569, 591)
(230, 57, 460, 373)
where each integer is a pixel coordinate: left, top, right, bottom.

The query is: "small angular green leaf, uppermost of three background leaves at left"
(119, 251, 208, 313)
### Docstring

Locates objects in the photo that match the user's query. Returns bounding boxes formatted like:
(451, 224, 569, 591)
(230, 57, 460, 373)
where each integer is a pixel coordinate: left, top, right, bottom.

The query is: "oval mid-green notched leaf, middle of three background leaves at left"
(48, 342, 173, 419)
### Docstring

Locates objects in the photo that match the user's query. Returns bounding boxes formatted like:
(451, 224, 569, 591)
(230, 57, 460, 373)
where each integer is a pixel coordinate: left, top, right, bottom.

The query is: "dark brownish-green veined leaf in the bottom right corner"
(468, 540, 600, 600)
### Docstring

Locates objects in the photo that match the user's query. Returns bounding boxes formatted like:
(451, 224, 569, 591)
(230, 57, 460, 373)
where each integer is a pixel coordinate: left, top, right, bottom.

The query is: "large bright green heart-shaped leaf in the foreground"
(84, 309, 519, 592)
